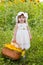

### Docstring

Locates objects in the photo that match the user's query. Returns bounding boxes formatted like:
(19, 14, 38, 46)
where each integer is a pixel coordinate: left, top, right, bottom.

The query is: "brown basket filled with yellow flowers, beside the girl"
(2, 44, 22, 60)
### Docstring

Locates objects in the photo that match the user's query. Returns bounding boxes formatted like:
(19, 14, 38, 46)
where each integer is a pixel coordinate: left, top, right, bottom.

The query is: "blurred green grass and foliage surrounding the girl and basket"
(0, 1, 43, 65)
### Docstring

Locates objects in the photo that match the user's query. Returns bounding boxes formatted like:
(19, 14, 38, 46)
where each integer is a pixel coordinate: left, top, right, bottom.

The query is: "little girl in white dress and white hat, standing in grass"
(12, 12, 32, 57)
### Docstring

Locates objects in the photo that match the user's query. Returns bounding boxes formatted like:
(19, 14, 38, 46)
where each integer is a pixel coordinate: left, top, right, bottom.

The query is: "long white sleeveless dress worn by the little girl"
(16, 23, 30, 50)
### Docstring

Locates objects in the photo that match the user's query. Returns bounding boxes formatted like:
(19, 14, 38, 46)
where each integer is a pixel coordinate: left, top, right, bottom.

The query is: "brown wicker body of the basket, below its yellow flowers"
(2, 43, 21, 60)
